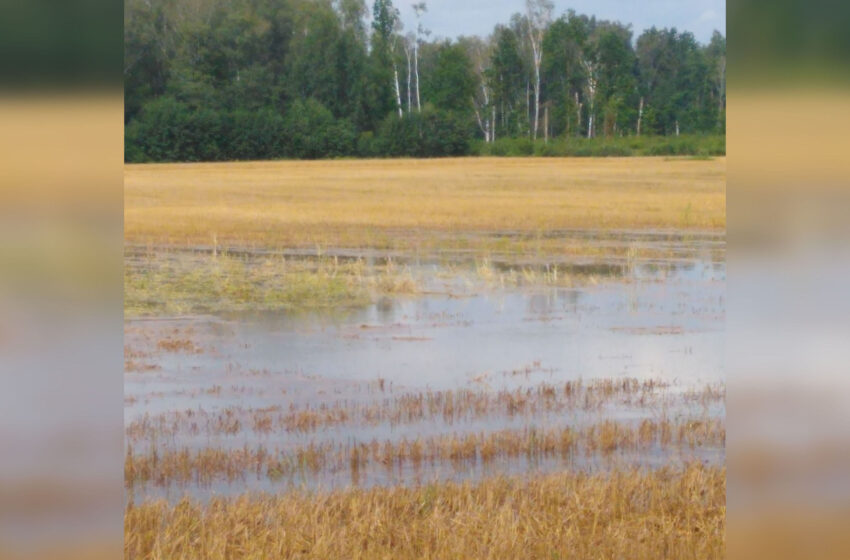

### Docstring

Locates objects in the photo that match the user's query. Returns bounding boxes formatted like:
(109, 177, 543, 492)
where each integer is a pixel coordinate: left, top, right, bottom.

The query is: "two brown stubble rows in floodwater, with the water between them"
(125, 372, 726, 488)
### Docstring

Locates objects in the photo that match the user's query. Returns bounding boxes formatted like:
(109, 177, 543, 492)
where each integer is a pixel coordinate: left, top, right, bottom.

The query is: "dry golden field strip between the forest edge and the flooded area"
(124, 158, 726, 247)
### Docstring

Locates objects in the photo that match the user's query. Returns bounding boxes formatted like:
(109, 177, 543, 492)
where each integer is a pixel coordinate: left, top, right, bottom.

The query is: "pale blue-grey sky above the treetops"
(390, 0, 726, 43)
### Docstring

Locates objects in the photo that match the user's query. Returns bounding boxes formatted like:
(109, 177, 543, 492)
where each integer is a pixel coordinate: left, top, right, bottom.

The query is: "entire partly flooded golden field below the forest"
(124, 158, 726, 558)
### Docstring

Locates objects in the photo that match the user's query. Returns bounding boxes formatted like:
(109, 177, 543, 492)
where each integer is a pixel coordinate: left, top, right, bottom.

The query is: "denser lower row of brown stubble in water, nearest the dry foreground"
(124, 419, 726, 487)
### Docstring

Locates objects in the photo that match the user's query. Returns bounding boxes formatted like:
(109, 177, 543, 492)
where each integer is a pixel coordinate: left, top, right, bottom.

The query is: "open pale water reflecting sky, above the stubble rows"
(125, 262, 725, 419)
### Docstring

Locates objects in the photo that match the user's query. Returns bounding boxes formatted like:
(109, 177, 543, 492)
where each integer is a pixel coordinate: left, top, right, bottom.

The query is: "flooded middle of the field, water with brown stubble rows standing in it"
(125, 230, 726, 499)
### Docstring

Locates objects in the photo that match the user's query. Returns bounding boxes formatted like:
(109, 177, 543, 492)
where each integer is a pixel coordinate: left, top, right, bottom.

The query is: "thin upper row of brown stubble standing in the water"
(125, 378, 708, 442)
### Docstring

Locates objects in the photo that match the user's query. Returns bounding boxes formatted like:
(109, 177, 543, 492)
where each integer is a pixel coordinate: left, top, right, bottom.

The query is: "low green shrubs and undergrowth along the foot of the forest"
(124, 96, 726, 162)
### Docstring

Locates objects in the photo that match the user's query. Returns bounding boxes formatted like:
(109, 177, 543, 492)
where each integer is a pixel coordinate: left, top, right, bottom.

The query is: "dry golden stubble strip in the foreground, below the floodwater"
(124, 465, 726, 560)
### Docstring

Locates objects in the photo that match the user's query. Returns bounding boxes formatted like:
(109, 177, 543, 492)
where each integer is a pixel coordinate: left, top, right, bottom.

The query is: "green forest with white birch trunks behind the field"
(124, 0, 726, 162)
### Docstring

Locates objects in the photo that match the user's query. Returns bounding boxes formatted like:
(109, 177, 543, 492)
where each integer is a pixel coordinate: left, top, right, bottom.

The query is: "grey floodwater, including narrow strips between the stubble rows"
(125, 249, 726, 496)
